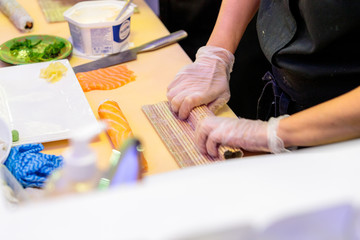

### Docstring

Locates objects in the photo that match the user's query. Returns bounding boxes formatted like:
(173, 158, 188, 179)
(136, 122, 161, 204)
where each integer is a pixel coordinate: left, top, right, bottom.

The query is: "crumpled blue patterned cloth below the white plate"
(4, 143, 63, 188)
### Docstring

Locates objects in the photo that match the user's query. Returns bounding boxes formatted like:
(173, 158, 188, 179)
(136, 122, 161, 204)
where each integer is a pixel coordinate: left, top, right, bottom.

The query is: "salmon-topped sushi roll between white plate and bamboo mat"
(98, 100, 147, 172)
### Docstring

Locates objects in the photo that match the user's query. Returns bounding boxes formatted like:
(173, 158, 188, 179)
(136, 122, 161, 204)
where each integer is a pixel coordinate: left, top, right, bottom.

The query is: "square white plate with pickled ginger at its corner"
(0, 59, 96, 145)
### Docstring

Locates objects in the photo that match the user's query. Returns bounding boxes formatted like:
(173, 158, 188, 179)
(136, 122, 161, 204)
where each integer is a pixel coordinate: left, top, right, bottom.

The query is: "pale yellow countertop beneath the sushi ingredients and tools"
(0, 0, 239, 175)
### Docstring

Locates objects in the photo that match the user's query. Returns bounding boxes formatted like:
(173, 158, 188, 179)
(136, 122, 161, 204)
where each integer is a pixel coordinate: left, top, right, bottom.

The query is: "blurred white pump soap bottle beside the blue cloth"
(45, 122, 105, 195)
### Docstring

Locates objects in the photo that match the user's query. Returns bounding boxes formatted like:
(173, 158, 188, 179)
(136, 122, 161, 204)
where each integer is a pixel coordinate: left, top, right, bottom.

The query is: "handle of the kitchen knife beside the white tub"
(136, 30, 187, 53)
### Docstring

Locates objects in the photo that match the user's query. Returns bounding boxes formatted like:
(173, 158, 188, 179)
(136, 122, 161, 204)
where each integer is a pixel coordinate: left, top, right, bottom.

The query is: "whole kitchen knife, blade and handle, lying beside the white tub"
(73, 30, 187, 73)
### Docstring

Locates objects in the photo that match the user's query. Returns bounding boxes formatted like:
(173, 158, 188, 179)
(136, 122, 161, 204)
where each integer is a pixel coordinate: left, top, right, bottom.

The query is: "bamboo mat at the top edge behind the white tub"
(38, 0, 139, 22)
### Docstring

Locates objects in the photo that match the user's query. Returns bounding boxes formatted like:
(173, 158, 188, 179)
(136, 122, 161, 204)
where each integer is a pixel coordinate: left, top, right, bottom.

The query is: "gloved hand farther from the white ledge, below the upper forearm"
(167, 46, 234, 119)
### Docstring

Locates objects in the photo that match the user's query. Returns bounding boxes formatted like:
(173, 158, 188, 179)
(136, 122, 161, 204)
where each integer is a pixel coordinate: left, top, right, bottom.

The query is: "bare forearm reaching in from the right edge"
(277, 87, 360, 147)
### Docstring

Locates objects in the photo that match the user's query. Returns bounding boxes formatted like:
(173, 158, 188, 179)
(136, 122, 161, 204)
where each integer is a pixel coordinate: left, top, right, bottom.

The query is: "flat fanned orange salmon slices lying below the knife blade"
(76, 65, 136, 92)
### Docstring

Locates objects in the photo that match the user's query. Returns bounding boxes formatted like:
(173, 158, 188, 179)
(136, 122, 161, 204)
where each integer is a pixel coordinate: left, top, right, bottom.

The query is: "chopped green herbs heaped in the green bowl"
(10, 38, 65, 62)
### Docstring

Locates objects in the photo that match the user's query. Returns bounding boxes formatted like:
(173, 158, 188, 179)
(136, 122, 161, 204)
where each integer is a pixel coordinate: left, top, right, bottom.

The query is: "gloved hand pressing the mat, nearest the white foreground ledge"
(195, 115, 289, 157)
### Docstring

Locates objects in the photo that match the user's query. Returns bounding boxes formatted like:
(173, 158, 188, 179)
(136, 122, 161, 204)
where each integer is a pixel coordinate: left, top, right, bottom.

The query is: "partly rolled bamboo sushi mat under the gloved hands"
(142, 102, 243, 168)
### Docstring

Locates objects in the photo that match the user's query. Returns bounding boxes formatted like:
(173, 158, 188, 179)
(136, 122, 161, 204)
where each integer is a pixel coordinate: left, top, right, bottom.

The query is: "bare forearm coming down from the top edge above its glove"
(206, 0, 260, 53)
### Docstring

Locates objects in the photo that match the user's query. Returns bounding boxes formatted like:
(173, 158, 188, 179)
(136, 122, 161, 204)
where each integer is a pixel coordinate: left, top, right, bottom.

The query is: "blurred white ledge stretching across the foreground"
(0, 139, 360, 239)
